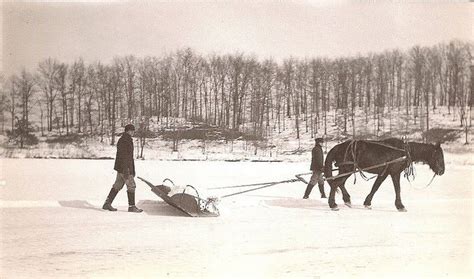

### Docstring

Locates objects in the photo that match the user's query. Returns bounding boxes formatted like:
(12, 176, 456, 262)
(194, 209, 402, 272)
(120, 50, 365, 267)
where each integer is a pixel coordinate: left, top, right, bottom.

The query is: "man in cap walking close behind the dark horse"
(303, 138, 326, 199)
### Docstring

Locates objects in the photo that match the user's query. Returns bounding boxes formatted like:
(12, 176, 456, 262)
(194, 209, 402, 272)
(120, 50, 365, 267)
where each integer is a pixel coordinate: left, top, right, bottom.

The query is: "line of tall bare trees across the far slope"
(0, 41, 474, 149)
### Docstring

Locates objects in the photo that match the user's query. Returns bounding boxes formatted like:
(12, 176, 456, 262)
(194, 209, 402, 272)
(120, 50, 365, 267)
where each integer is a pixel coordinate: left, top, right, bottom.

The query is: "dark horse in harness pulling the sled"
(324, 138, 444, 211)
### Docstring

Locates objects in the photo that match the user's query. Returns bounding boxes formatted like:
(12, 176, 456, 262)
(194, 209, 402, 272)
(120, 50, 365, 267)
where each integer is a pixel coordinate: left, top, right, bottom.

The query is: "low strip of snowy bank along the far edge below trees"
(0, 136, 474, 165)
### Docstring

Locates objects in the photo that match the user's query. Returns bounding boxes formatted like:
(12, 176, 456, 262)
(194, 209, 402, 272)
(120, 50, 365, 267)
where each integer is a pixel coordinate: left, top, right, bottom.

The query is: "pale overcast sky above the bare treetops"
(2, 0, 474, 75)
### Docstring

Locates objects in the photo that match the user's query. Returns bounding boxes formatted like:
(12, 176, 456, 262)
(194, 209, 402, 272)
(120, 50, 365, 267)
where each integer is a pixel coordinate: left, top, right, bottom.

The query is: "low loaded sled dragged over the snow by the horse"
(138, 177, 219, 217)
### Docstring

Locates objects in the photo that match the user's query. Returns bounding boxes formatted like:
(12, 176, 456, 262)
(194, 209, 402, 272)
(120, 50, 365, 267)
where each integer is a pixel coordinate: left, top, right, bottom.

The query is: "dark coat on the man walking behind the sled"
(114, 133, 135, 176)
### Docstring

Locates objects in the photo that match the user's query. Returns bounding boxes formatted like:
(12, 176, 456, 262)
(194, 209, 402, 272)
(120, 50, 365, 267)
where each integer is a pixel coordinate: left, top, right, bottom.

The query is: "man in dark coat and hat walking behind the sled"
(102, 124, 143, 212)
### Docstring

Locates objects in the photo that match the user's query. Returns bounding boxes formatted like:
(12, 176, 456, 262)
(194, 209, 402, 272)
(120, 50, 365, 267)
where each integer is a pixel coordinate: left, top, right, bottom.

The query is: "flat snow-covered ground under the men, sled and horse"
(0, 159, 474, 278)
